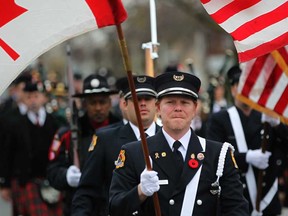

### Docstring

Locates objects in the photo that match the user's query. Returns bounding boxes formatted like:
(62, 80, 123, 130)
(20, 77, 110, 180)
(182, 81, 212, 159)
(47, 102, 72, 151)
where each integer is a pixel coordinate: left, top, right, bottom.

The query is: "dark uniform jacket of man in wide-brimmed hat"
(47, 110, 121, 215)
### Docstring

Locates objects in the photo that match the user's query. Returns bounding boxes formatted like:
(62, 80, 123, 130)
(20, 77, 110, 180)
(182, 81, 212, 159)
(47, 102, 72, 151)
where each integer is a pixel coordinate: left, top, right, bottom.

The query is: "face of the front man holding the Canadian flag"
(157, 95, 197, 133)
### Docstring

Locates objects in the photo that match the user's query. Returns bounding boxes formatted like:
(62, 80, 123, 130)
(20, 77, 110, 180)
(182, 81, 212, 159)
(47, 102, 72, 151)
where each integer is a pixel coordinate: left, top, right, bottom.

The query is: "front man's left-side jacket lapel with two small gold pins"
(148, 131, 179, 183)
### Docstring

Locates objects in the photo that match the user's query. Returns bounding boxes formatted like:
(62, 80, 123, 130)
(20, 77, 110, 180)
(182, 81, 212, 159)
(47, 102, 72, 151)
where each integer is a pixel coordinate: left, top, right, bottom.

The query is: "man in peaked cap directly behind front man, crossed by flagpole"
(72, 76, 160, 216)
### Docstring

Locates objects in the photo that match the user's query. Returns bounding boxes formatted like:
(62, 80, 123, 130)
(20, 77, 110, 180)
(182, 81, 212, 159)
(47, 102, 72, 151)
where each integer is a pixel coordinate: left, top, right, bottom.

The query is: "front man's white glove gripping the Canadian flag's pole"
(140, 169, 160, 196)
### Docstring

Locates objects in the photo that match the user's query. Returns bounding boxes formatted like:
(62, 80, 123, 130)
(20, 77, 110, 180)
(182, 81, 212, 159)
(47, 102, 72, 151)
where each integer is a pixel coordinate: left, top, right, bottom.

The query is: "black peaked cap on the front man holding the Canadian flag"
(155, 71, 201, 100)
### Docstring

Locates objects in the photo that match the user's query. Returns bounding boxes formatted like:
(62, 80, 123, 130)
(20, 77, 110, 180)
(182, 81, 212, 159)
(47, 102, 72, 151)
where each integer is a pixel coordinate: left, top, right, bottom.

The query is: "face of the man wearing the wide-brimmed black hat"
(84, 94, 111, 123)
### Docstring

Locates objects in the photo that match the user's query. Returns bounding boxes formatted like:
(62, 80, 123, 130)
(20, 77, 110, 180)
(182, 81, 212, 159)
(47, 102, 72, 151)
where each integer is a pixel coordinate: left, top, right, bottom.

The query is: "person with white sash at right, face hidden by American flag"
(206, 65, 288, 216)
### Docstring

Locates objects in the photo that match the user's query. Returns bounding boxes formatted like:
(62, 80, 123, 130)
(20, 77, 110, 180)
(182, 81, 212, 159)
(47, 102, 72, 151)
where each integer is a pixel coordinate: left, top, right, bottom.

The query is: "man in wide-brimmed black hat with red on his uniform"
(47, 75, 120, 216)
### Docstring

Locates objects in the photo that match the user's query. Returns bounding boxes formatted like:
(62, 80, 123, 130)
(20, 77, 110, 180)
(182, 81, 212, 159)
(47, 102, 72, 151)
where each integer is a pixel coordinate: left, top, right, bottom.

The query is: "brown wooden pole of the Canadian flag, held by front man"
(116, 24, 161, 216)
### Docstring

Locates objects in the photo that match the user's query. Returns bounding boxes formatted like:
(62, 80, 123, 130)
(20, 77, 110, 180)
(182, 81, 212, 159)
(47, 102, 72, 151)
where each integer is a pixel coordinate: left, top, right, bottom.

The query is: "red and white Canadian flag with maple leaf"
(0, 0, 127, 95)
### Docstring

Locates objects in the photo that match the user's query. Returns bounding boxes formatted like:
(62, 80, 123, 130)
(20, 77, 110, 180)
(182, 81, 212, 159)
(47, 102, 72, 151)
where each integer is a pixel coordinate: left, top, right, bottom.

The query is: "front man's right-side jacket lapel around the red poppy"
(175, 131, 205, 193)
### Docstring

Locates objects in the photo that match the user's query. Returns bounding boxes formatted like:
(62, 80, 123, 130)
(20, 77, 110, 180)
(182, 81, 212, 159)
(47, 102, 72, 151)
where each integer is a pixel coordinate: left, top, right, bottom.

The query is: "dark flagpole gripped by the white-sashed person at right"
(256, 122, 269, 212)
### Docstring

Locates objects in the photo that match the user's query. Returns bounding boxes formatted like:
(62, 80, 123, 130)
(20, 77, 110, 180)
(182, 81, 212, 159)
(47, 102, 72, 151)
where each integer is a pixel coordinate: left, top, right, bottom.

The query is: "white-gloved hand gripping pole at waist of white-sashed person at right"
(246, 149, 271, 169)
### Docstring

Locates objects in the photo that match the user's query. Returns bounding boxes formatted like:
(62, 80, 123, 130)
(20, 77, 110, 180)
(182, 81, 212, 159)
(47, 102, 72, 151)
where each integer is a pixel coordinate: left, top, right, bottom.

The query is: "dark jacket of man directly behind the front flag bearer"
(72, 123, 160, 216)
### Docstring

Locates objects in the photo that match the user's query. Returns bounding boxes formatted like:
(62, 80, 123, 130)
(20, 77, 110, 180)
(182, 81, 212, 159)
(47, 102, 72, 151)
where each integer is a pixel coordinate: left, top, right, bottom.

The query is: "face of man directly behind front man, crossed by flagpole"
(126, 96, 156, 128)
